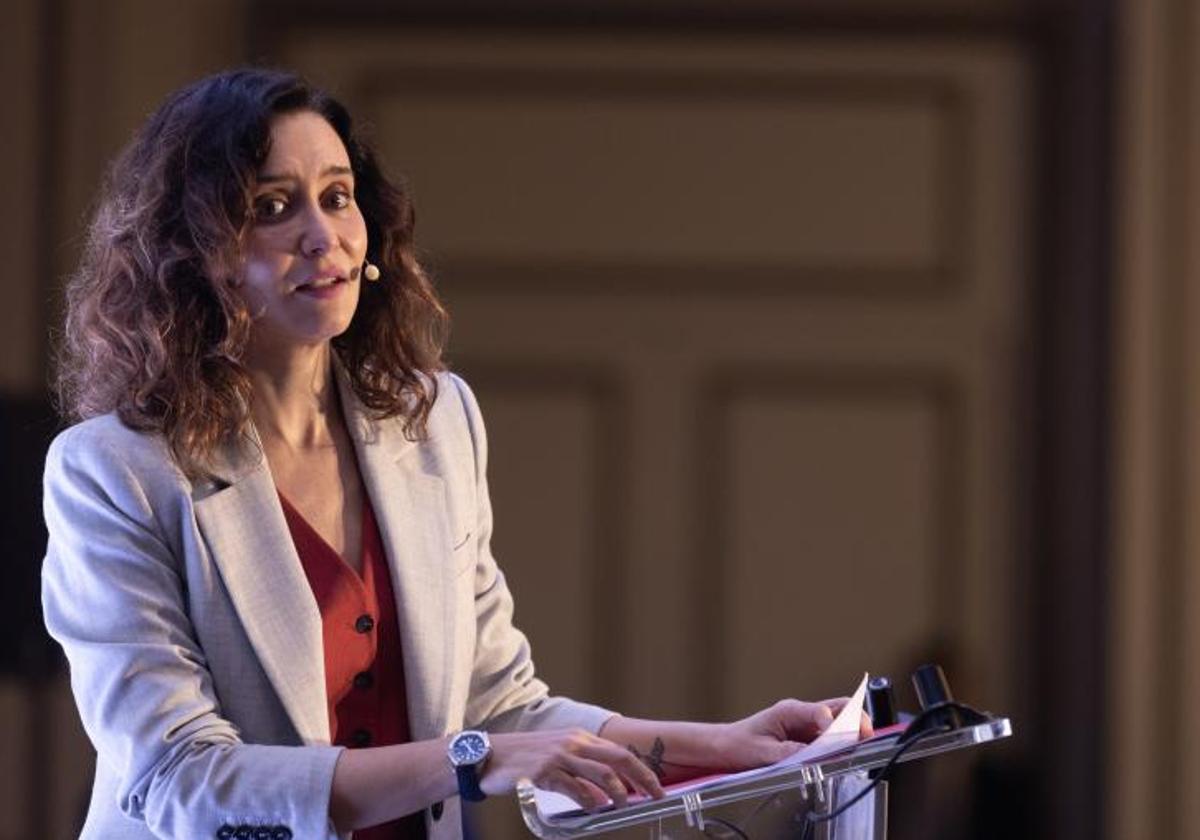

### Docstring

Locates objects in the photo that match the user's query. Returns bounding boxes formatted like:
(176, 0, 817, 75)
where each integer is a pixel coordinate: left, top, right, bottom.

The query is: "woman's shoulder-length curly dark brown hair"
(56, 70, 448, 476)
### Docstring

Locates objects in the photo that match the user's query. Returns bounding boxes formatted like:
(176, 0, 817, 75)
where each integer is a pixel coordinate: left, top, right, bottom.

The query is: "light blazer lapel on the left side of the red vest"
(196, 442, 329, 744)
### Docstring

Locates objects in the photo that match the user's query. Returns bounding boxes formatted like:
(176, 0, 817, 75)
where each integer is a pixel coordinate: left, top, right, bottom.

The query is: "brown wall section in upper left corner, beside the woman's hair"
(0, 0, 245, 394)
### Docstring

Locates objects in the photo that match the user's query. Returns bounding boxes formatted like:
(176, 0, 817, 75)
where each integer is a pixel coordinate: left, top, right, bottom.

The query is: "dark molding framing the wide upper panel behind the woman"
(346, 61, 978, 300)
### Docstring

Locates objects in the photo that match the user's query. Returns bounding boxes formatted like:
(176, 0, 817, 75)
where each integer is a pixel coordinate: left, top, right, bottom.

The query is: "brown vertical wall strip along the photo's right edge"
(1108, 0, 1200, 838)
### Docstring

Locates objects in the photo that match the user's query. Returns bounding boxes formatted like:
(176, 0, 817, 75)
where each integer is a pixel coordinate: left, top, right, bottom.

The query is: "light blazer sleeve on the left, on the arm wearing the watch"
(42, 424, 341, 840)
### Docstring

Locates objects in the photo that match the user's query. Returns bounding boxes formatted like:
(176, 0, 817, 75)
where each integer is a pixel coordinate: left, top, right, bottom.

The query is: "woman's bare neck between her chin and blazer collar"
(247, 343, 338, 450)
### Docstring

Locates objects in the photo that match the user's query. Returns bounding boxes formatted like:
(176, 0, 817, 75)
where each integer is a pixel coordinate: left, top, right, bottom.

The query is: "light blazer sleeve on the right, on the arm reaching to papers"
(450, 374, 613, 732)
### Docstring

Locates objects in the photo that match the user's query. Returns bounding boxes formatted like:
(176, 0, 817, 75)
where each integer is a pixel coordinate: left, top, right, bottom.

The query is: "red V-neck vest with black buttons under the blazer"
(280, 493, 425, 840)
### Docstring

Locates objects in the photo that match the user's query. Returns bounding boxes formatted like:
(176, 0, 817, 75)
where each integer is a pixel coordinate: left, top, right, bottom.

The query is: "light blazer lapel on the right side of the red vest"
(338, 376, 456, 740)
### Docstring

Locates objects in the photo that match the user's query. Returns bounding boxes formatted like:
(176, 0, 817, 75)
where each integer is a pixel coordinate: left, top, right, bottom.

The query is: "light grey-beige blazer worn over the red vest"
(42, 374, 610, 840)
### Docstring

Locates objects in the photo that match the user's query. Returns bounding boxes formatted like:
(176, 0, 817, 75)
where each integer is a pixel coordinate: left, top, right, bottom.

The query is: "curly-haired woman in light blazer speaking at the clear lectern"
(43, 71, 868, 840)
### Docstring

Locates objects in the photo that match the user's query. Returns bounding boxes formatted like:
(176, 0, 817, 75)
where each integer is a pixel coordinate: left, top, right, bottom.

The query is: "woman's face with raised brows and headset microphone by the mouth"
(239, 110, 367, 350)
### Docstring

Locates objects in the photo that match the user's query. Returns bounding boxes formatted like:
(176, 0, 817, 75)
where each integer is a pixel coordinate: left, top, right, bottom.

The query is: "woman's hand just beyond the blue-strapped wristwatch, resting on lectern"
(480, 730, 662, 809)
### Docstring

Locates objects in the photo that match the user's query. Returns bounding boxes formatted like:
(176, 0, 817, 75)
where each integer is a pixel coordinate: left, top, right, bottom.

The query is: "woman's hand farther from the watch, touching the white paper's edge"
(720, 697, 874, 769)
